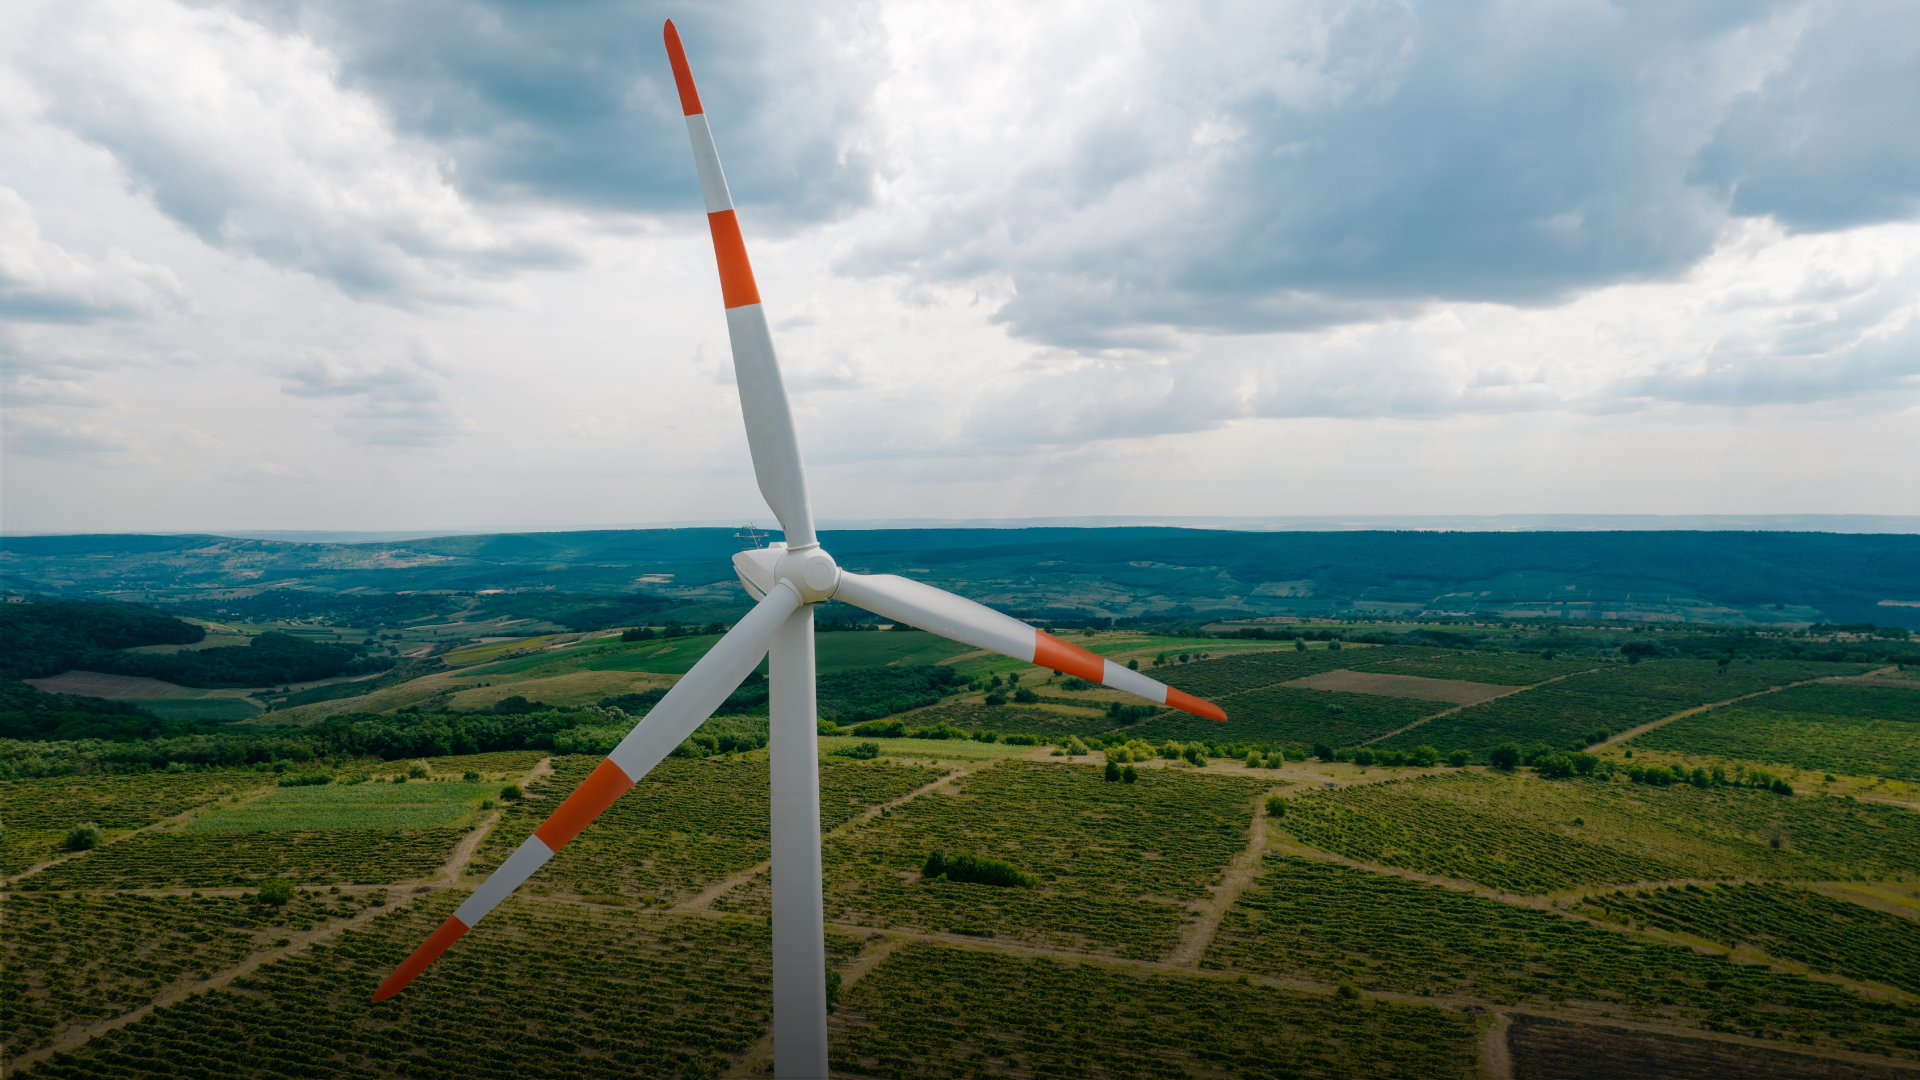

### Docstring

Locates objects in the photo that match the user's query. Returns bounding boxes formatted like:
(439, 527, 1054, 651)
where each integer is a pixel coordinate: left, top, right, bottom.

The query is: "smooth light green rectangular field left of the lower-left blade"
(180, 780, 499, 834)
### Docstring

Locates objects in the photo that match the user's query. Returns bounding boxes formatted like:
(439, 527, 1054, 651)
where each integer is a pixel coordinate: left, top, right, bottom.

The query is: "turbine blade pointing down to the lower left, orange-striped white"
(372, 582, 801, 1001)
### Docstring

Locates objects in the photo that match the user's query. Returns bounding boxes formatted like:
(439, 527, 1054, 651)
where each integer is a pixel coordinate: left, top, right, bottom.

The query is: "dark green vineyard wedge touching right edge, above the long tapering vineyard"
(1586, 882, 1920, 994)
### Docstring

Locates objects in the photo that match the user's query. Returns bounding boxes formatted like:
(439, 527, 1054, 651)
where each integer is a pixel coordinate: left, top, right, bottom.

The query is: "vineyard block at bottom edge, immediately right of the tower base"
(831, 944, 1478, 1080)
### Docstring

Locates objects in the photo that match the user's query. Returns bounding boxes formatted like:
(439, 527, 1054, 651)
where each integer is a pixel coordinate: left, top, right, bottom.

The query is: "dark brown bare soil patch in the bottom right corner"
(1507, 1013, 1920, 1080)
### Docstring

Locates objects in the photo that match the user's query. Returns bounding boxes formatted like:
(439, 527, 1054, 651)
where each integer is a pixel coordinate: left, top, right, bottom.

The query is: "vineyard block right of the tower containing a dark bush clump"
(824, 759, 1267, 959)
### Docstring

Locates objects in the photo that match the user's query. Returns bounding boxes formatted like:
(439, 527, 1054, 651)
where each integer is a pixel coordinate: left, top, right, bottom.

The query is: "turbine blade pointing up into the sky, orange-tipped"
(666, 21, 818, 548)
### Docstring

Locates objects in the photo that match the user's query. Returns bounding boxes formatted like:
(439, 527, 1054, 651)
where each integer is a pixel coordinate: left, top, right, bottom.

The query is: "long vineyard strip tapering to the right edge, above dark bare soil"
(1204, 855, 1920, 1057)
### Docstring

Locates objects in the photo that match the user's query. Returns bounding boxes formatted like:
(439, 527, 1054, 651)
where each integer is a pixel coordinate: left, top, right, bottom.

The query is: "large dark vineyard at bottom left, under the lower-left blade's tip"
(20, 892, 770, 1080)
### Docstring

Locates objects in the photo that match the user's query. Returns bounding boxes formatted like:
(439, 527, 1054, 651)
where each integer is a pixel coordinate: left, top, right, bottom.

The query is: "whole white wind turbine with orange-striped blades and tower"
(372, 21, 1227, 1080)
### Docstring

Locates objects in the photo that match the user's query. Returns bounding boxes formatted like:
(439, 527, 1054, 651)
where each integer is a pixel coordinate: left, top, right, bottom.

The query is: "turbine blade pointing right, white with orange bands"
(833, 571, 1227, 721)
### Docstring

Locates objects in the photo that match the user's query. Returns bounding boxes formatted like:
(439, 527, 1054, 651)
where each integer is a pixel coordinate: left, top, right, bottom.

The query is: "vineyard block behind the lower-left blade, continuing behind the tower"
(468, 755, 945, 903)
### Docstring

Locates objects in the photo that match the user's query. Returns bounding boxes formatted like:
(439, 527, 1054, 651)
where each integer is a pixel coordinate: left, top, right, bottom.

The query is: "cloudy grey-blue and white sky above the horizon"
(0, 0, 1920, 532)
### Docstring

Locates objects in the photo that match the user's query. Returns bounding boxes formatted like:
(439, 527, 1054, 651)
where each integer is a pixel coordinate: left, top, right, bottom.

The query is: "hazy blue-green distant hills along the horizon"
(0, 528, 1920, 626)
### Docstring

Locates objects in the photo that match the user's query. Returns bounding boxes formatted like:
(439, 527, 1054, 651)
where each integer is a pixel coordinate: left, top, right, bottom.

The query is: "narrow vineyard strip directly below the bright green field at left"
(15, 828, 468, 892)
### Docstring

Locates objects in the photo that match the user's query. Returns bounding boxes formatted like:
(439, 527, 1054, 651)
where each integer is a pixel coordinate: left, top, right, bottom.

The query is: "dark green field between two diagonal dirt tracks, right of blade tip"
(1386, 659, 1864, 759)
